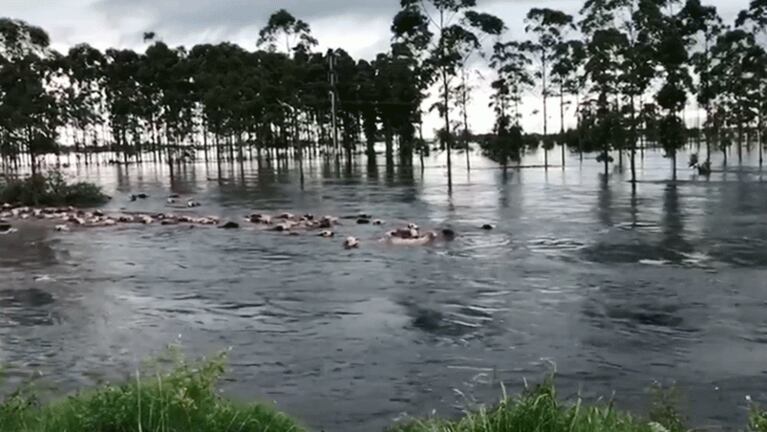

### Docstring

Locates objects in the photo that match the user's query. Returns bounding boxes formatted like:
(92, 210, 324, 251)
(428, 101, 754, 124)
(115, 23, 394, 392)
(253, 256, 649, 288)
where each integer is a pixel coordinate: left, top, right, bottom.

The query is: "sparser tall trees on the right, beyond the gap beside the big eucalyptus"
(486, 0, 767, 181)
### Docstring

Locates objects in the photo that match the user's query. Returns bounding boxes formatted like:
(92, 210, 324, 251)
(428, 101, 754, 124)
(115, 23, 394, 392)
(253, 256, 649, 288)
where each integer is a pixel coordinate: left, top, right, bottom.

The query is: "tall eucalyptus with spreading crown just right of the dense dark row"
(392, 0, 504, 187)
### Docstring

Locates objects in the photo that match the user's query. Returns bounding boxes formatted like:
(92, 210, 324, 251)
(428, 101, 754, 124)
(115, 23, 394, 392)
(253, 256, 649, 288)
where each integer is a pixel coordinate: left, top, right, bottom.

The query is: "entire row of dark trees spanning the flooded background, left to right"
(0, 0, 767, 181)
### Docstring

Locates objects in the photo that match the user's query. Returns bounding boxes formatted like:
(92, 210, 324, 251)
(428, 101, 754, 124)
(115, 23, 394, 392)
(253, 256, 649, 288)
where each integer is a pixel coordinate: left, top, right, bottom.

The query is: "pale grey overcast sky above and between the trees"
(0, 0, 748, 131)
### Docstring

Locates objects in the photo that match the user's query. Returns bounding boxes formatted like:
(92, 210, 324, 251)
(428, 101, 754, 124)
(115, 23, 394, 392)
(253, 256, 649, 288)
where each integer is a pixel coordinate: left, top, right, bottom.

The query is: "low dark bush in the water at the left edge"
(0, 171, 109, 206)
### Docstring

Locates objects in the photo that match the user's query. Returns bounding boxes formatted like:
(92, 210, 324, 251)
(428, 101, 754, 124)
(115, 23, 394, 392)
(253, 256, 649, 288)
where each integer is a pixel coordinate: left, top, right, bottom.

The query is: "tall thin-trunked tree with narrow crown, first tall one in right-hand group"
(525, 8, 575, 167)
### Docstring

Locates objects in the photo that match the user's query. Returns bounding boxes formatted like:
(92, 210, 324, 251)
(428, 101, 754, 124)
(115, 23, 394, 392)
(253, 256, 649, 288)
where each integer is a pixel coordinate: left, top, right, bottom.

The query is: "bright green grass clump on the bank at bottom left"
(0, 357, 303, 432)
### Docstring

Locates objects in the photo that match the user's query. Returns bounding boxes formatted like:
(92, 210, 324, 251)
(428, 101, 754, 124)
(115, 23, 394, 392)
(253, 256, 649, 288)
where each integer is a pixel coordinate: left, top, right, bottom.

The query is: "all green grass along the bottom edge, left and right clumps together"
(0, 351, 767, 432)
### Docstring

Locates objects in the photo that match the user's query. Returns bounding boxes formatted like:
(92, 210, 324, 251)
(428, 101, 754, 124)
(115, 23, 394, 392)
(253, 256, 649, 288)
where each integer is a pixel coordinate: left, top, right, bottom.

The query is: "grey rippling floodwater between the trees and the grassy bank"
(0, 147, 767, 432)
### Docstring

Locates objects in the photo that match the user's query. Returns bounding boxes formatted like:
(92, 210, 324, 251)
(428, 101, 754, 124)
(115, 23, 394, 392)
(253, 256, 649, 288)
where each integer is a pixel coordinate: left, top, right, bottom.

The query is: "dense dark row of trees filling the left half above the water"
(0, 11, 421, 177)
